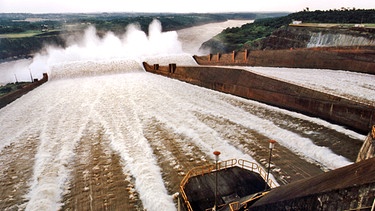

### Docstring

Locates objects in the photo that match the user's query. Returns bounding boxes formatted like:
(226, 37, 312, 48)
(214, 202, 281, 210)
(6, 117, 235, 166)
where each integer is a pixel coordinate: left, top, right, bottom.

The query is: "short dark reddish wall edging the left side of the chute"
(0, 73, 48, 109)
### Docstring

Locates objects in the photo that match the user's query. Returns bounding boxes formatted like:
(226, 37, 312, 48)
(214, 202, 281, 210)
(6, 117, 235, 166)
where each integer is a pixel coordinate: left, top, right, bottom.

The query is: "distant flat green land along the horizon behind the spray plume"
(0, 13, 286, 61)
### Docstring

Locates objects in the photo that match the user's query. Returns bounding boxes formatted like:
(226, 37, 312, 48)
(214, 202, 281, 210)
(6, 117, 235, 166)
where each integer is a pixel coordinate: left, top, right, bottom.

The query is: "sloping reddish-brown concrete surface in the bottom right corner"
(249, 158, 375, 210)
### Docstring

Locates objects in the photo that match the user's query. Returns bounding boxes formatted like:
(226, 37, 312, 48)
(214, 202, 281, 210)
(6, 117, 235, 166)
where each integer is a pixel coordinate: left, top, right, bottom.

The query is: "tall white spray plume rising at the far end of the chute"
(29, 19, 183, 79)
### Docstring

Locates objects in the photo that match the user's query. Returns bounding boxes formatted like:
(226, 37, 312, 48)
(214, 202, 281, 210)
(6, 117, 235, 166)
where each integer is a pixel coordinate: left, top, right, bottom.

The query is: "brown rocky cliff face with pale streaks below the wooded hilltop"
(248, 23, 375, 50)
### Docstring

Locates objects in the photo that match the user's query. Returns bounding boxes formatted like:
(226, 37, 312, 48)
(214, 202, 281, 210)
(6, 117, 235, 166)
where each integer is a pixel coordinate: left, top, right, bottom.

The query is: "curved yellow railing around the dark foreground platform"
(180, 159, 277, 211)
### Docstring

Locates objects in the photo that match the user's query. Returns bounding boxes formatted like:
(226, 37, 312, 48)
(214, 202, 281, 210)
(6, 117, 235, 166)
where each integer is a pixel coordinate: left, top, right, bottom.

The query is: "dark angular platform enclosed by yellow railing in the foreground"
(180, 160, 274, 211)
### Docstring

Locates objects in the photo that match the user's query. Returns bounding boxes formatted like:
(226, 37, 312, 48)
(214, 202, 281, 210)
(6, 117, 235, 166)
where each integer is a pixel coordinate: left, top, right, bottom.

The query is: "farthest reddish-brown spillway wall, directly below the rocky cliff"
(194, 46, 375, 74)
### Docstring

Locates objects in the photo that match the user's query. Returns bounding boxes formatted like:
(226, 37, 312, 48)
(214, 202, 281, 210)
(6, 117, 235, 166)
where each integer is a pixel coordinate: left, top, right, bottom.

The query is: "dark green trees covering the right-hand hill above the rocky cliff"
(203, 9, 375, 54)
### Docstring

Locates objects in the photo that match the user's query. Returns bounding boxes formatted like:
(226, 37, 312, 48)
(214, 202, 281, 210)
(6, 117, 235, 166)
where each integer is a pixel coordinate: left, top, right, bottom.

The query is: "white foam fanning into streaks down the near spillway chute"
(0, 68, 364, 210)
